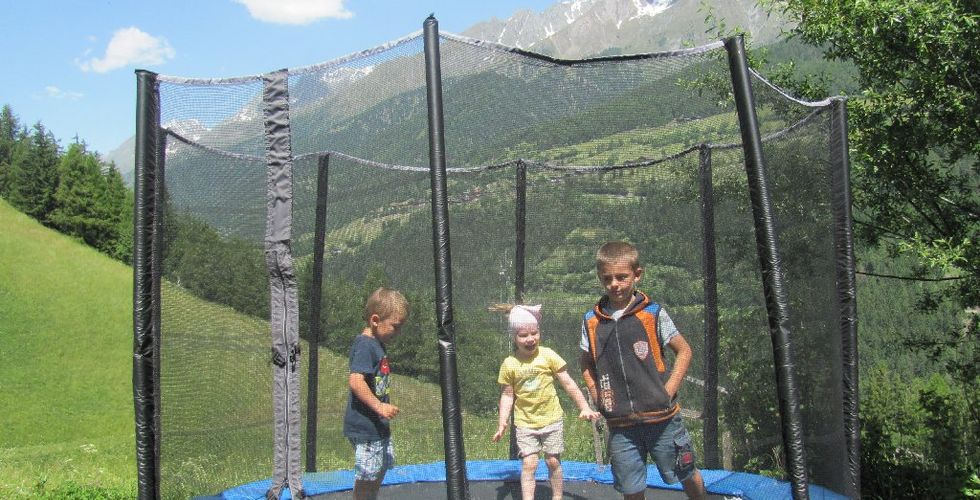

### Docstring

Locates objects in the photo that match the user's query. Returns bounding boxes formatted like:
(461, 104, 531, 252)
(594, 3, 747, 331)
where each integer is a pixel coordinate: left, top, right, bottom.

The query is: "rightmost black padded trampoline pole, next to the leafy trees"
(830, 98, 861, 498)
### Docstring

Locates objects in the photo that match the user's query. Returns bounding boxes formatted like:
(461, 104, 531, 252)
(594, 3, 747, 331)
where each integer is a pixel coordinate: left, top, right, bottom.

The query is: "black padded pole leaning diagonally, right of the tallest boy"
(725, 36, 809, 500)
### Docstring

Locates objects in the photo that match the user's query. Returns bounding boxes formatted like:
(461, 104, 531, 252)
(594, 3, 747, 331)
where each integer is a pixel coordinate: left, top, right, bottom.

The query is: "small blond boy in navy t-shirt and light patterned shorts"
(344, 287, 409, 500)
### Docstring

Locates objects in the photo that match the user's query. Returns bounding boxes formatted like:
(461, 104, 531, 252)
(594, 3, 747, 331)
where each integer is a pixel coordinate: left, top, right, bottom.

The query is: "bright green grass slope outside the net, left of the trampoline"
(0, 200, 136, 498)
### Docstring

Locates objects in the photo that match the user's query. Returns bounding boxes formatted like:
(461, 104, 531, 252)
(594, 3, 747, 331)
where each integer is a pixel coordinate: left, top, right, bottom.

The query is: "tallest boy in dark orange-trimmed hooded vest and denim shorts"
(579, 241, 705, 500)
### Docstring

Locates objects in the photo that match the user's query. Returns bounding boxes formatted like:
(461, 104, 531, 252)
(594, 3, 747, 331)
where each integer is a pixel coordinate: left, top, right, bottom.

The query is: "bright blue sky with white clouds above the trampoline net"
(0, 0, 555, 154)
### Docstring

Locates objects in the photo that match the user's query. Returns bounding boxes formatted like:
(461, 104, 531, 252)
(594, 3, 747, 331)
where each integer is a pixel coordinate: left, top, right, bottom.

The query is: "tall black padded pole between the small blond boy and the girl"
(423, 16, 470, 500)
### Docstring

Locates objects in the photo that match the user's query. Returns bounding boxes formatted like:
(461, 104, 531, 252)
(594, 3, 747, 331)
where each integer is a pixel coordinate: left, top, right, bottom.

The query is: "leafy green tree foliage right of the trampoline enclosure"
(744, 0, 980, 498)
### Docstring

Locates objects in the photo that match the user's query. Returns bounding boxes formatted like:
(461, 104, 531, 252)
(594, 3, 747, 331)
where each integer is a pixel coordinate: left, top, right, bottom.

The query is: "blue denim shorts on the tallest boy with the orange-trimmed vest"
(609, 414, 696, 495)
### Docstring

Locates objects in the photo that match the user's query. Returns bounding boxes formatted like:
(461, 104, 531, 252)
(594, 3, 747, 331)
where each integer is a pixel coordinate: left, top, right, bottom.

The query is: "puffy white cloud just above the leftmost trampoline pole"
(76, 26, 177, 73)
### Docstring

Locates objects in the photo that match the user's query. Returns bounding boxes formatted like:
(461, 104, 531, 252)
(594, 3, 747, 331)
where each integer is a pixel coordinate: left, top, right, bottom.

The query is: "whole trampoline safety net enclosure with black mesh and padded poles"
(134, 18, 858, 498)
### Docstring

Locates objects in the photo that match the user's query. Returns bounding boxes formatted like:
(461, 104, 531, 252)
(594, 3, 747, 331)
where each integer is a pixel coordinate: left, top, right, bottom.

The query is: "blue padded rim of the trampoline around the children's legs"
(194, 460, 847, 500)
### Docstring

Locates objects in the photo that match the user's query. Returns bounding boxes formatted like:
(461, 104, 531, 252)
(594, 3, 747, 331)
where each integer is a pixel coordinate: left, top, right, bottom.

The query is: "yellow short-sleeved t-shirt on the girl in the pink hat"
(497, 346, 565, 429)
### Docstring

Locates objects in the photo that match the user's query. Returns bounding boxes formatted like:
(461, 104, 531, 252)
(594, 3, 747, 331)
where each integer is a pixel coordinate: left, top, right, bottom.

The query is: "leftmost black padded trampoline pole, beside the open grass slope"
(133, 70, 163, 500)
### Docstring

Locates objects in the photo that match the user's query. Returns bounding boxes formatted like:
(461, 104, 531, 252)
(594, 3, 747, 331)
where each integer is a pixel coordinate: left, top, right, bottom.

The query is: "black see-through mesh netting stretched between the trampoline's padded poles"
(142, 30, 847, 498)
